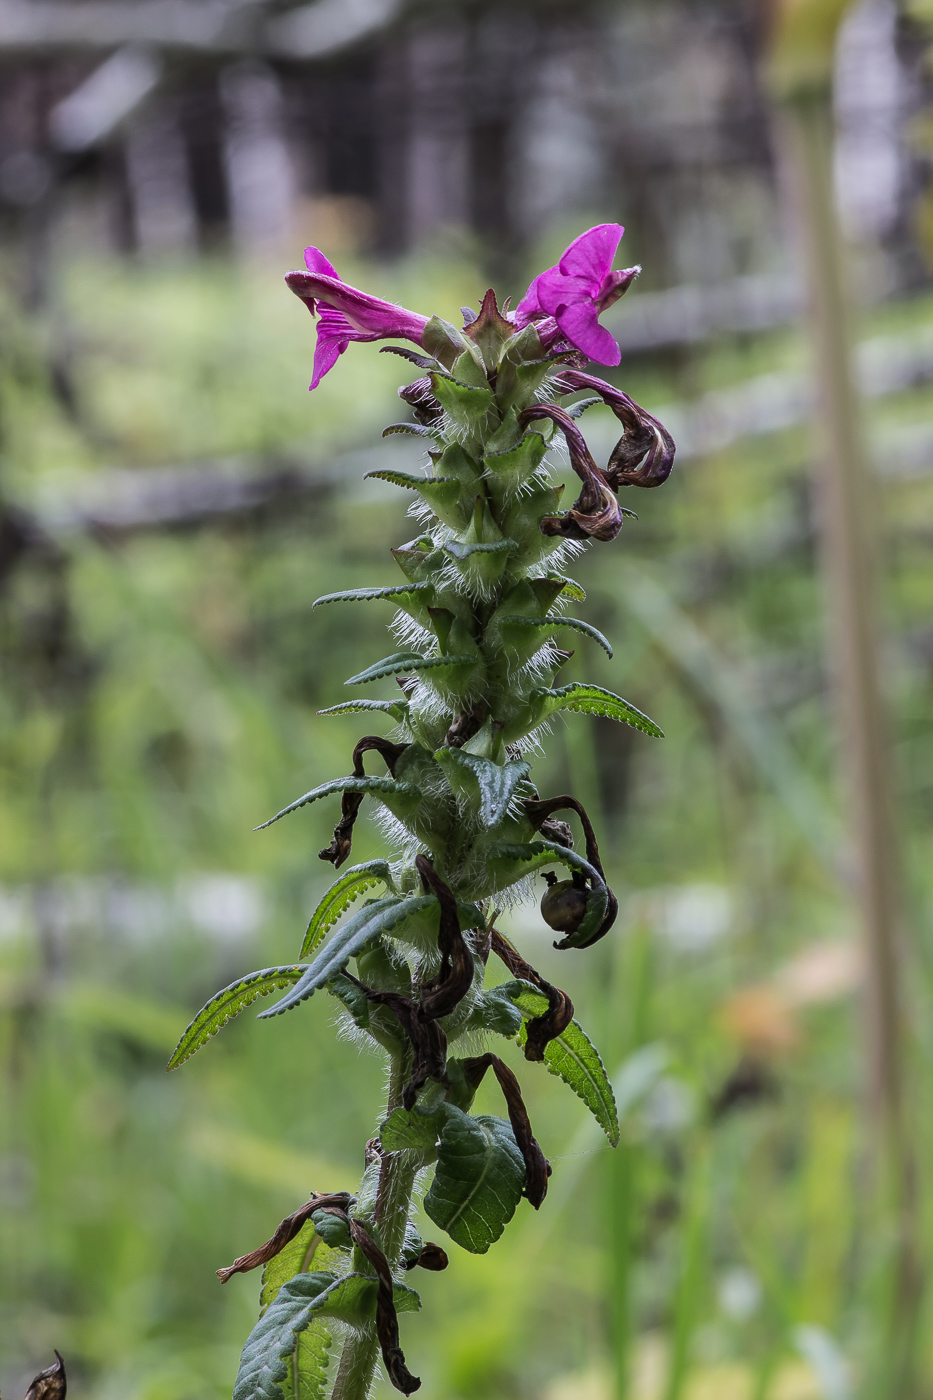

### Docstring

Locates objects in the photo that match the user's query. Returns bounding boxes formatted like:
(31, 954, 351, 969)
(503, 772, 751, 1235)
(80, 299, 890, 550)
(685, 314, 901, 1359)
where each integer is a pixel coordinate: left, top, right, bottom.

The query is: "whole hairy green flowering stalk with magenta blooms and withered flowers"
(170, 224, 674, 1400)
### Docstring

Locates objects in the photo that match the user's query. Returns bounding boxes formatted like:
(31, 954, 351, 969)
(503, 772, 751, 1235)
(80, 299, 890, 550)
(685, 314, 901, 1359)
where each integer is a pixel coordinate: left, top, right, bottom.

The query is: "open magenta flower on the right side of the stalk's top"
(514, 224, 640, 364)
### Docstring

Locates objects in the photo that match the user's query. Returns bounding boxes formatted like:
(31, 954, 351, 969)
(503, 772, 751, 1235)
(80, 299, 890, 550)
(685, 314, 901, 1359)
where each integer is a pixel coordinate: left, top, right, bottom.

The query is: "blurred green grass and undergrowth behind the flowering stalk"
(0, 252, 933, 1400)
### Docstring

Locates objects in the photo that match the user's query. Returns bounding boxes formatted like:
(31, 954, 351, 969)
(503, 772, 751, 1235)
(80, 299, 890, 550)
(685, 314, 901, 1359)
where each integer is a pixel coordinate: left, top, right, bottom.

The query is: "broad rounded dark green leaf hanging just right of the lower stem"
(424, 1103, 525, 1254)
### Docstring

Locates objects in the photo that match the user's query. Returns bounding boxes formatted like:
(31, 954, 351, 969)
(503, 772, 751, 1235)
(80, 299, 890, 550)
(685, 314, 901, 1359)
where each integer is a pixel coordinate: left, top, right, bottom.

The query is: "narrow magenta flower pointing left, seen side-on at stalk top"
(286, 248, 427, 389)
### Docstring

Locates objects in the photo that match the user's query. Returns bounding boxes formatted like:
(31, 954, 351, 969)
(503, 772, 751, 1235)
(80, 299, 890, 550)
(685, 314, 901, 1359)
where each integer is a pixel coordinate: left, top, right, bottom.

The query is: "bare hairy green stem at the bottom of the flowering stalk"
(331, 1054, 415, 1400)
